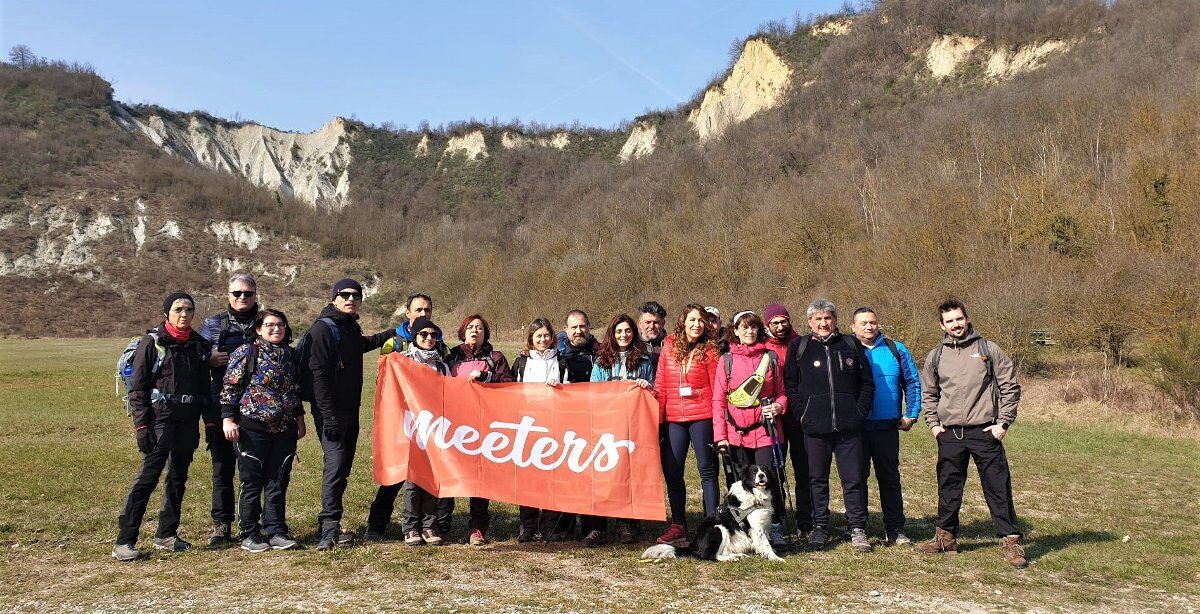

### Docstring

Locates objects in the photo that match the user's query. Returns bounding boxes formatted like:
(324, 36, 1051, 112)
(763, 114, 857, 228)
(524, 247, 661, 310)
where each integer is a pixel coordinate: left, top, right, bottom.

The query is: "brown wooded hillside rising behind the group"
(0, 0, 1200, 412)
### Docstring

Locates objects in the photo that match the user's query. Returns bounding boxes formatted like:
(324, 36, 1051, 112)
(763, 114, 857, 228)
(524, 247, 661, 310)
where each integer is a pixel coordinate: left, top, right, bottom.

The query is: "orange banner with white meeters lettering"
(373, 354, 666, 520)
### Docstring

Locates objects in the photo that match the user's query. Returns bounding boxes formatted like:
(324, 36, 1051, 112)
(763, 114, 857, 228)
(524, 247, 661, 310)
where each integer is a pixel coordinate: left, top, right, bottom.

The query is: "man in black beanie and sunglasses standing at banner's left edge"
(307, 278, 396, 550)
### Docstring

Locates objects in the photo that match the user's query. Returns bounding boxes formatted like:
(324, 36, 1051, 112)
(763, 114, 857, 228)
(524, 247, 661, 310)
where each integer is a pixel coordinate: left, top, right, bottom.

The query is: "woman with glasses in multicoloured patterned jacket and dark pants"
(221, 309, 305, 552)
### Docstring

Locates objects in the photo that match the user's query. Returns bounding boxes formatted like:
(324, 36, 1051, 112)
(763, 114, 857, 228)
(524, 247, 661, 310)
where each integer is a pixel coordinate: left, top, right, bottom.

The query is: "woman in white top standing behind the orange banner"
(512, 318, 566, 543)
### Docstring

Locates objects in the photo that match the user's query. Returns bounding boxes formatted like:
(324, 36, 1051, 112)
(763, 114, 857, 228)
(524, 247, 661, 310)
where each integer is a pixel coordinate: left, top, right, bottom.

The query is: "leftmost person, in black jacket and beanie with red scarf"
(113, 291, 217, 561)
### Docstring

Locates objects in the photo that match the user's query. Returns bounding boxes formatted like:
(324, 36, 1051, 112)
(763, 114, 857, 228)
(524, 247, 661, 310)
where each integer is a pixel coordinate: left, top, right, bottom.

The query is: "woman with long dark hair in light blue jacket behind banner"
(580, 313, 658, 548)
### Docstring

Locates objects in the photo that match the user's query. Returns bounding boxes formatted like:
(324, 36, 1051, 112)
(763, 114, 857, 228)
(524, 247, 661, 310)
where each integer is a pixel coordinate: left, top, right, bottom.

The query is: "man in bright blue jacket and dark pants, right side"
(852, 307, 920, 546)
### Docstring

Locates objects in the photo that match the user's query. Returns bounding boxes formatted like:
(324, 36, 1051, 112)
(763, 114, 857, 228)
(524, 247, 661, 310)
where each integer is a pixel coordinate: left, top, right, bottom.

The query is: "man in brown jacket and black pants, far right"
(917, 299, 1026, 568)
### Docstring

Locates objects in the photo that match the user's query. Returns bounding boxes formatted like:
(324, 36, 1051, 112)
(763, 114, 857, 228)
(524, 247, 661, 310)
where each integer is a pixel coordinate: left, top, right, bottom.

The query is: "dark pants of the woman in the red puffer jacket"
(659, 420, 721, 525)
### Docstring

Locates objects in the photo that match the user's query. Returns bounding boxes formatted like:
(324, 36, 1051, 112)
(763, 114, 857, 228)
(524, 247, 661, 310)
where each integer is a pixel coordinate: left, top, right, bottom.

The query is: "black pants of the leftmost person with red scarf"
(116, 419, 200, 546)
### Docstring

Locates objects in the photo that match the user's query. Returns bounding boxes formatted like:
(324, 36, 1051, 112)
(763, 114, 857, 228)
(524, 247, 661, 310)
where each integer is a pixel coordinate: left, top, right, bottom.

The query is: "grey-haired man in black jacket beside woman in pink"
(784, 299, 875, 552)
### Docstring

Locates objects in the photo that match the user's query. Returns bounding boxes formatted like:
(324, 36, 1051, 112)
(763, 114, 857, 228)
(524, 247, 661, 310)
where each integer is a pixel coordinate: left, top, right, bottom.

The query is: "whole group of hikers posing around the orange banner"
(113, 275, 1026, 567)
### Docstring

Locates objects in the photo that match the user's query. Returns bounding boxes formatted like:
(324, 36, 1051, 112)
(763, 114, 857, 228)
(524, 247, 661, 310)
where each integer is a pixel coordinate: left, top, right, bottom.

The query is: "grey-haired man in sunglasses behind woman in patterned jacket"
(200, 273, 258, 548)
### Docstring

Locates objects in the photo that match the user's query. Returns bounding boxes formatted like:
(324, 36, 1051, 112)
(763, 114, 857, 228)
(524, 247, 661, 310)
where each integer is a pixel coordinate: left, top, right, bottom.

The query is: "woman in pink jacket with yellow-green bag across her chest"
(713, 311, 787, 548)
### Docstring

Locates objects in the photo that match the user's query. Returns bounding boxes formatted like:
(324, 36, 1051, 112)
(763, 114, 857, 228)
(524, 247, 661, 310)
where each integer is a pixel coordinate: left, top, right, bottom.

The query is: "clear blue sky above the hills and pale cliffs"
(0, 0, 842, 131)
